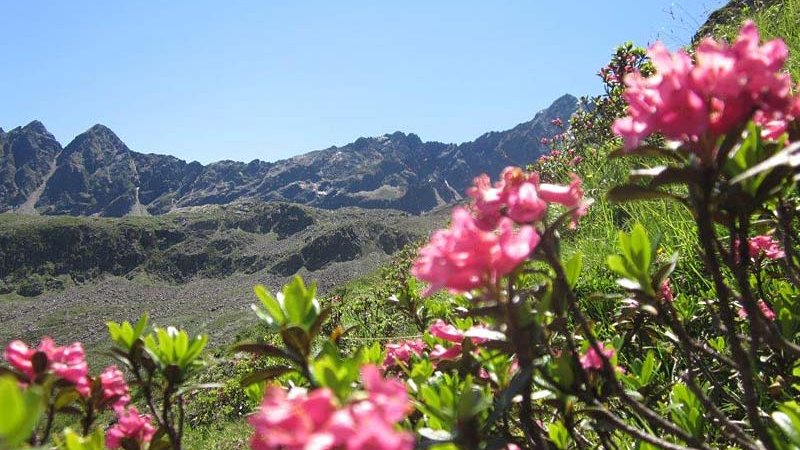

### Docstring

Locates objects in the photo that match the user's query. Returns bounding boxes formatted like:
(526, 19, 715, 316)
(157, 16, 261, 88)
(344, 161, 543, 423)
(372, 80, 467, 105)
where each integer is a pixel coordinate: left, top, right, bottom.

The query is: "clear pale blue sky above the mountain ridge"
(0, 0, 723, 162)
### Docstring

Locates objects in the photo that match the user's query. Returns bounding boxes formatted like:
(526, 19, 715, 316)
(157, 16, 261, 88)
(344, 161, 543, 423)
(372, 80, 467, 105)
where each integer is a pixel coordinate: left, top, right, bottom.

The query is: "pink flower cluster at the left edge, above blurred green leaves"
(4, 337, 91, 397)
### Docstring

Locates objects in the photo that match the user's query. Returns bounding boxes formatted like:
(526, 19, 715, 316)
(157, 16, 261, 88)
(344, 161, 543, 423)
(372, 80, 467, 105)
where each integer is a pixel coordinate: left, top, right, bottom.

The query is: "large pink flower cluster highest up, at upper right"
(612, 22, 792, 153)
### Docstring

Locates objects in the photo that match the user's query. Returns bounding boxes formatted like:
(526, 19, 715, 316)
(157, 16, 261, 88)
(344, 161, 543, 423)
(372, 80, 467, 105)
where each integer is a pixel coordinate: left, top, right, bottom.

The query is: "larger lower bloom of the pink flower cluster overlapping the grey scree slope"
(411, 208, 539, 295)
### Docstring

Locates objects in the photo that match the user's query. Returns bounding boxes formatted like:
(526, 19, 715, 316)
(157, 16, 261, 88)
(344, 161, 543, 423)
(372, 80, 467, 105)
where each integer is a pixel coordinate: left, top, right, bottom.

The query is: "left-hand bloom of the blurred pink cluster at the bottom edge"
(249, 387, 336, 450)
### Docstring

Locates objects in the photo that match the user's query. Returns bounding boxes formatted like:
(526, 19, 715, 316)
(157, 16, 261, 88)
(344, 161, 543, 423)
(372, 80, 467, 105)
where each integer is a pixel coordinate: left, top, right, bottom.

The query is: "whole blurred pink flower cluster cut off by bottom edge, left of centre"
(250, 365, 414, 450)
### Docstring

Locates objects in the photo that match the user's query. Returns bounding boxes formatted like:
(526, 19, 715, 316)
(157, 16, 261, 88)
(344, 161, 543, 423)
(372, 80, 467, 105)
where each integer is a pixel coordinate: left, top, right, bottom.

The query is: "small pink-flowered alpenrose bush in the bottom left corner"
(0, 316, 207, 450)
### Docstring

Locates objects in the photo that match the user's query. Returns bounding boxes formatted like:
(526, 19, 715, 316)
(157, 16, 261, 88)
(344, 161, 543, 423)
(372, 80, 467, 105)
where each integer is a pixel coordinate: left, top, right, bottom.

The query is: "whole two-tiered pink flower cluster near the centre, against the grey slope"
(411, 167, 587, 295)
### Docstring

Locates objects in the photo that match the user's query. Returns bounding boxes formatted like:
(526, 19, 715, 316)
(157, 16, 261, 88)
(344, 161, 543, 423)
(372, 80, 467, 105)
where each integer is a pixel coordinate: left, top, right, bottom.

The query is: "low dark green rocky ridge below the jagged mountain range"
(0, 200, 446, 296)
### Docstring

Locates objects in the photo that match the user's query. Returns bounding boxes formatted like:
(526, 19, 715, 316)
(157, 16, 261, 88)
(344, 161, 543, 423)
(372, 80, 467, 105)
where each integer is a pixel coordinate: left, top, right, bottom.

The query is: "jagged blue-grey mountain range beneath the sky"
(0, 95, 577, 217)
